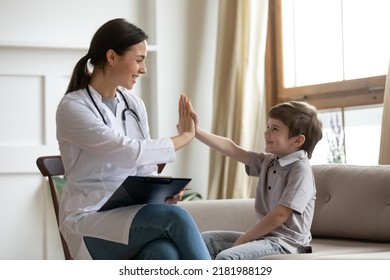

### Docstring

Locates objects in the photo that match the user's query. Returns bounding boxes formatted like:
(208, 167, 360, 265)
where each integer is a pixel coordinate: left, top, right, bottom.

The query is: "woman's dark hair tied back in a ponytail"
(65, 18, 148, 94)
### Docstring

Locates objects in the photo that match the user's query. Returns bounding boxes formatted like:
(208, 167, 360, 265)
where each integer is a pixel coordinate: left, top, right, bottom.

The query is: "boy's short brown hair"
(268, 101, 322, 158)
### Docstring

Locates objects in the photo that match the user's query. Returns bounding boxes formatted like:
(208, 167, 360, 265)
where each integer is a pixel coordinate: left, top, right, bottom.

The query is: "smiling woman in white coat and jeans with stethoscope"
(56, 19, 210, 259)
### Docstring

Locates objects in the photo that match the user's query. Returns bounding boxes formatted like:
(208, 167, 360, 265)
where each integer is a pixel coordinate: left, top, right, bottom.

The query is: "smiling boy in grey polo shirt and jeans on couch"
(192, 101, 322, 260)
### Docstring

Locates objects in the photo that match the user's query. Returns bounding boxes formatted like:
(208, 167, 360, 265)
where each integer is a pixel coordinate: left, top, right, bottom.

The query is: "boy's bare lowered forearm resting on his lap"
(233, 204, 293, 246)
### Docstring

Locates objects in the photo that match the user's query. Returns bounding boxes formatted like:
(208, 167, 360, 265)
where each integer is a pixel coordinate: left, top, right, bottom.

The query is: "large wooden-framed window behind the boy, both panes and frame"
(266, 0, 390, 164)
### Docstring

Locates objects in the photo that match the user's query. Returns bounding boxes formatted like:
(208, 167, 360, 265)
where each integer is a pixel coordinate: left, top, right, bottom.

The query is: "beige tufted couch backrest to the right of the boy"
(312, 164, 390, 242)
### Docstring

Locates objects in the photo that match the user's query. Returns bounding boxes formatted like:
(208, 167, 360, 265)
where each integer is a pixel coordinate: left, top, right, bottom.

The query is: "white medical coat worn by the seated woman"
(56, 86, 175, 259)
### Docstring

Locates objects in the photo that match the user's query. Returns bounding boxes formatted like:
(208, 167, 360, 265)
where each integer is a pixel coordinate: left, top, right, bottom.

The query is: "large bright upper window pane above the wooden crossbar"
(282, 0, 390, 88)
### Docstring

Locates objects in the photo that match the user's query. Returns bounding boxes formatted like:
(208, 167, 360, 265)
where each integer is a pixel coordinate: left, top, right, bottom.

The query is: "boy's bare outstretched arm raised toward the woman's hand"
(195, 126, 250, 164)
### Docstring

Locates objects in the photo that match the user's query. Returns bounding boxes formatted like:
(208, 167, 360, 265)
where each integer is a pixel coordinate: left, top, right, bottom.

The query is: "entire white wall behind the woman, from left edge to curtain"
(0, 0, 218, 259)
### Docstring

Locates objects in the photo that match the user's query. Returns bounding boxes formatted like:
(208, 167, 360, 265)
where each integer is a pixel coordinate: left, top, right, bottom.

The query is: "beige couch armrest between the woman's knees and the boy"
(179, 198, 256, 232)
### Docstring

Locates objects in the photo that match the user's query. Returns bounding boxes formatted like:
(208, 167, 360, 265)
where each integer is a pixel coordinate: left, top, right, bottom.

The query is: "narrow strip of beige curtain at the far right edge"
(378, 60, 390, 164)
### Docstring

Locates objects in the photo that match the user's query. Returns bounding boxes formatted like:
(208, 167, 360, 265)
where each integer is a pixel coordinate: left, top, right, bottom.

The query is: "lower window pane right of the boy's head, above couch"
(311, 104, 383, 165)
